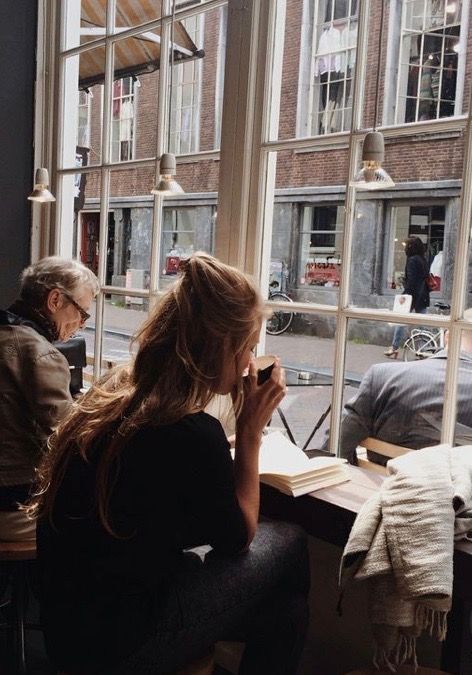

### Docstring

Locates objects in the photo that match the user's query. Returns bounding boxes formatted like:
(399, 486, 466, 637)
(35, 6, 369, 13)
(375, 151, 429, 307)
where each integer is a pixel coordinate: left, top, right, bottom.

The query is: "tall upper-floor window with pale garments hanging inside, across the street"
(299, 0, 357, 136)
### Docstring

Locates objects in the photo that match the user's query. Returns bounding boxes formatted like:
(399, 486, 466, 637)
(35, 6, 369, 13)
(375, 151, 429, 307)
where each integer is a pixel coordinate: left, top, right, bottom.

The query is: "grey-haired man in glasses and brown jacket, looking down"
(0, 256, 98, 541)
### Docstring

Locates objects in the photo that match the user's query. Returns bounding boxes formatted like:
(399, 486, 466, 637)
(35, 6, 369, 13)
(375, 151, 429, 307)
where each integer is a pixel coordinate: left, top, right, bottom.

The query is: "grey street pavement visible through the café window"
(83, 301, 385, 448)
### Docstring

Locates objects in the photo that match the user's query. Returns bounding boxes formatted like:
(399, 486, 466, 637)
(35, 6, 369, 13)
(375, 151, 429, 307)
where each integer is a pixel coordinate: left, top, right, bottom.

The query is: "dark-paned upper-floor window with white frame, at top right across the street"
(396, 0, 462, 124)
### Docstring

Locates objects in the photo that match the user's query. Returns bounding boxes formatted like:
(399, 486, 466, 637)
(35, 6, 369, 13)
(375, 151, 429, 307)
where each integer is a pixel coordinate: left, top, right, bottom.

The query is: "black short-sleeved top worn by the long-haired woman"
(38, 412, 247, 671)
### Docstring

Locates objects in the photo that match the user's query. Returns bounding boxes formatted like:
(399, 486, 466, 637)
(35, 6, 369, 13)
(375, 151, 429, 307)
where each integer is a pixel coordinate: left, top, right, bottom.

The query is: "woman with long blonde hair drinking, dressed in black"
(31, 253, 308, 675)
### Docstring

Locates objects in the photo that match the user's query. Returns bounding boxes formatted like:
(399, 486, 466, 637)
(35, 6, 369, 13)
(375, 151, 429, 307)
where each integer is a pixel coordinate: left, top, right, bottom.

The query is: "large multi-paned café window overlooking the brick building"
(45, 0, 472, 468)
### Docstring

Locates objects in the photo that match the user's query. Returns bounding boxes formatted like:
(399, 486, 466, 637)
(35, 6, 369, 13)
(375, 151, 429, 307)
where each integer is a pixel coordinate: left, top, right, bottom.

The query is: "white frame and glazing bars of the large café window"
(39, 0, 472, 451)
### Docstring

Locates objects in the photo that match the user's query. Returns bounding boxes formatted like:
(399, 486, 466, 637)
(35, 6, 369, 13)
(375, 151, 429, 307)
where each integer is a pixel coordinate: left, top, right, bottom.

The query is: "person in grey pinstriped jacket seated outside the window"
(323, 309, 472, 464)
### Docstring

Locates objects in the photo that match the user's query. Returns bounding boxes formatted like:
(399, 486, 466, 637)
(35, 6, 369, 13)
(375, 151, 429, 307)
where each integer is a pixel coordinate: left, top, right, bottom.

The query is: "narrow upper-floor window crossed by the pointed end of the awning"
(170, 14, 204, 155)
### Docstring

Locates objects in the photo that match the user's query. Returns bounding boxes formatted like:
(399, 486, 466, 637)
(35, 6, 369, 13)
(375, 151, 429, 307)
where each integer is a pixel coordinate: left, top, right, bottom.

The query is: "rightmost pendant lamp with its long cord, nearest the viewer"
(351, 0, 395, 190)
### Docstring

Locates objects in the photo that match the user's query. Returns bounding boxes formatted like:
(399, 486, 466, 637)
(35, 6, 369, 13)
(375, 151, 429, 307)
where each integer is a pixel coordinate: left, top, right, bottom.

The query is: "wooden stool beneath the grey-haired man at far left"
(0, 539, 36, 674)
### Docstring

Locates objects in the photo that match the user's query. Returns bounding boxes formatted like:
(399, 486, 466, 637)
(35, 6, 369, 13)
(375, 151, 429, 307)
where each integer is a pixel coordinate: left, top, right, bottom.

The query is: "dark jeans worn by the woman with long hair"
(112, 522, 309, 675)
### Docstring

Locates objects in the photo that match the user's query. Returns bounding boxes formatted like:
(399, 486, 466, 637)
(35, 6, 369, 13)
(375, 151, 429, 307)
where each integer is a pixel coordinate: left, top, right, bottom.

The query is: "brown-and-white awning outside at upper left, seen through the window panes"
(79, 0, 205, 89)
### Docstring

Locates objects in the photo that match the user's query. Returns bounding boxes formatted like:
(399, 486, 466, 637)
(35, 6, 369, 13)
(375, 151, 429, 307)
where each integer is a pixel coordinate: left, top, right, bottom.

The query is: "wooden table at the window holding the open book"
(261, 466, 472, 675)
